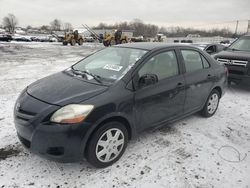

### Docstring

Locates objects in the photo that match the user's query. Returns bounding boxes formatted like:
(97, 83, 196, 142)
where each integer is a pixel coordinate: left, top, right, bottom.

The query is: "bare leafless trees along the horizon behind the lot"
(2, 14, 239, 37)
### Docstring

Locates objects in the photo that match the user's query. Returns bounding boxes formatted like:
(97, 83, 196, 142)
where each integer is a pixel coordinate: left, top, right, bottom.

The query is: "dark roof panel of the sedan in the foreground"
(115, 42, 197, 51)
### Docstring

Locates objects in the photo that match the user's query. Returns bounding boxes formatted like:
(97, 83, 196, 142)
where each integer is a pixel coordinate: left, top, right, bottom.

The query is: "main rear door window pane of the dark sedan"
(181, 50, 203, 72)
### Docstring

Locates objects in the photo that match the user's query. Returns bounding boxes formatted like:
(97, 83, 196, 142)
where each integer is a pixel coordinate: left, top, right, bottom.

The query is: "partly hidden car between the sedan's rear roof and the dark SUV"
(192, 43, 225, 55)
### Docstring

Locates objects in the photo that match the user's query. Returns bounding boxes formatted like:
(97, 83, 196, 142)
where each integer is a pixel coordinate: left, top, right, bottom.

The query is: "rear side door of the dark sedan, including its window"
(180, 49, 215, 113)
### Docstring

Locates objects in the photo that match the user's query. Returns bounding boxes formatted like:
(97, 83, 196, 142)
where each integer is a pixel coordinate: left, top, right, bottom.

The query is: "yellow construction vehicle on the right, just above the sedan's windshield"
(103, 30, 129, 46)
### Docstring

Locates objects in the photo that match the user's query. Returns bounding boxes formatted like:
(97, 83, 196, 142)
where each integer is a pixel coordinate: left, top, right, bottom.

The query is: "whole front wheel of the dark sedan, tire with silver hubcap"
(86, 122, 128, 168)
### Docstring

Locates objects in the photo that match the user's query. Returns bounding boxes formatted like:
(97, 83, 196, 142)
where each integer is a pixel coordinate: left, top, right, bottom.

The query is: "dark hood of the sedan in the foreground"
(27, 72, 108, 106)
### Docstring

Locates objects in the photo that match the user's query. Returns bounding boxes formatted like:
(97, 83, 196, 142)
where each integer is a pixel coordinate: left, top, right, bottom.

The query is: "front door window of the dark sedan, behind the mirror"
(138, 51, 179, 80)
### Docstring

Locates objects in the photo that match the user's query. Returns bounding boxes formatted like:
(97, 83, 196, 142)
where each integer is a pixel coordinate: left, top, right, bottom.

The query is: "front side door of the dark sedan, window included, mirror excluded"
(133, 50, 185, 130)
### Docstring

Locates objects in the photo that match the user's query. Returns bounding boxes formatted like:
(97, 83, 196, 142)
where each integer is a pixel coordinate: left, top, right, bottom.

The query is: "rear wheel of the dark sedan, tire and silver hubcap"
(201, 89, 220, 117)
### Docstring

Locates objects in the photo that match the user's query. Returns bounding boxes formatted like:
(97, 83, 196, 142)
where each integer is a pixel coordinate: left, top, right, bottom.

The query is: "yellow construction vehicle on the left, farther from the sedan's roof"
(63, 30, 84, 46)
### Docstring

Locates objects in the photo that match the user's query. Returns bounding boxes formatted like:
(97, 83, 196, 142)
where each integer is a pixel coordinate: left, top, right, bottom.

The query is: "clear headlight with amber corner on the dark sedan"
(50, 104, 94, 123)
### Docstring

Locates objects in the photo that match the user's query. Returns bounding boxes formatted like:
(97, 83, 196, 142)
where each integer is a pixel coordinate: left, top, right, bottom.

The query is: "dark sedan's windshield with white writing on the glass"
(72, 47, 147, 82)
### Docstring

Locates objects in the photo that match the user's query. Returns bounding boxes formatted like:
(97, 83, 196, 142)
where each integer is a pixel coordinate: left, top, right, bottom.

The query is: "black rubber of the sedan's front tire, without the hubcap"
(86, 121, 128, 168)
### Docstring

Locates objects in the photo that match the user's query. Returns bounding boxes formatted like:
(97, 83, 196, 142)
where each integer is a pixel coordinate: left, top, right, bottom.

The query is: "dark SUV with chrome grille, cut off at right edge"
(214, 35, 250, 85)
